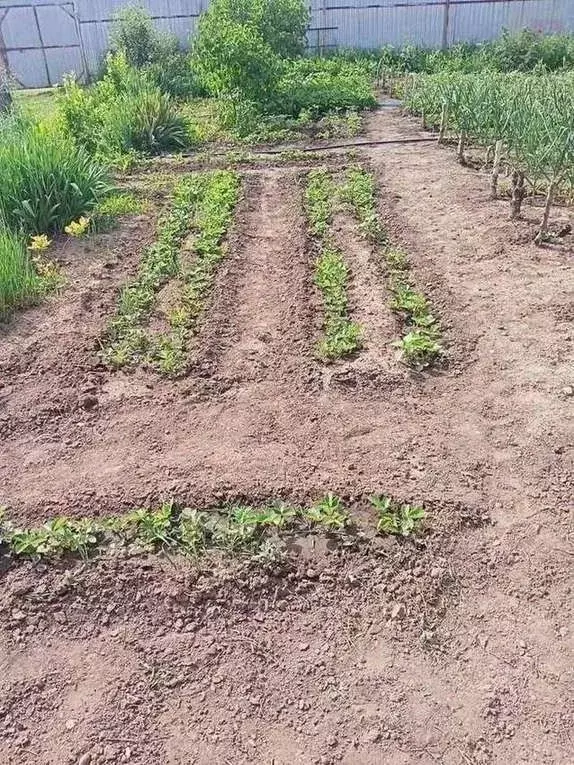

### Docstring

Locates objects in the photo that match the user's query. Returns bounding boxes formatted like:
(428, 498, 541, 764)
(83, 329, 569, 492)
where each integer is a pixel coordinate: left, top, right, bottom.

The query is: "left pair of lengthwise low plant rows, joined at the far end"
(103, 170, 240, 375)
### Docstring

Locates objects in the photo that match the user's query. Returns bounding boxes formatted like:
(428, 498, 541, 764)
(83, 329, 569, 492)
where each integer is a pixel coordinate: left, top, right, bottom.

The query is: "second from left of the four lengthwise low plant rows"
(150, 170, 240, 376)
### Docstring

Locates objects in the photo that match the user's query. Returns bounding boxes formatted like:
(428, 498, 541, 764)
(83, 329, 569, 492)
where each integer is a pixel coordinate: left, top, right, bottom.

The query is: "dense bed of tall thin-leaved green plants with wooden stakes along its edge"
(405, 72, 574, 243)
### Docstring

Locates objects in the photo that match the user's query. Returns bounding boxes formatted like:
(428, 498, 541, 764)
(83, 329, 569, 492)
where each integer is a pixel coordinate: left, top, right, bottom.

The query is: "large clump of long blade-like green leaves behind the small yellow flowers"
(0, 120, 110, 234)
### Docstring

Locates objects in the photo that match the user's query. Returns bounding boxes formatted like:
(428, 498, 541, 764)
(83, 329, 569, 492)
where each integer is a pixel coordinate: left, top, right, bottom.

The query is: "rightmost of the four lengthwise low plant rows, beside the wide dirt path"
(342, 168, 443, 369)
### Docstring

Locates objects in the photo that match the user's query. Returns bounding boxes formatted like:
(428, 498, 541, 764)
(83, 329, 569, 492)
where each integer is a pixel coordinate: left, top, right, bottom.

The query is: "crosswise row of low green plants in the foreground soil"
(0, 494, 426, 559)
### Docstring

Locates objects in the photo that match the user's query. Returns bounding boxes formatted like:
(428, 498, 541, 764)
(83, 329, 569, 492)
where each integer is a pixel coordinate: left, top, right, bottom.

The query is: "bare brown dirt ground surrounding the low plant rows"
(0, 110, 574, 765)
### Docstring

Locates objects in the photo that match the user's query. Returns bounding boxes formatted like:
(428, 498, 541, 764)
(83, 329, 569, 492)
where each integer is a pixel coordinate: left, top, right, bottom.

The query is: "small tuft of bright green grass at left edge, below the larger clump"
(0, 223, 42, 319)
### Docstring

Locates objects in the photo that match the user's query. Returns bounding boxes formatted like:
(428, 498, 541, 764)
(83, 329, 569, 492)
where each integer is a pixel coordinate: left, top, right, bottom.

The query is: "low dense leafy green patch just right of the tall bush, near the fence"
(276, 58, 377, 117)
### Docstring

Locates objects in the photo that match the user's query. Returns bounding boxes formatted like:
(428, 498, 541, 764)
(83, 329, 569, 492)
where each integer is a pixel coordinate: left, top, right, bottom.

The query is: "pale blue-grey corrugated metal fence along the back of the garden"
(0, 0, 574, 88)
